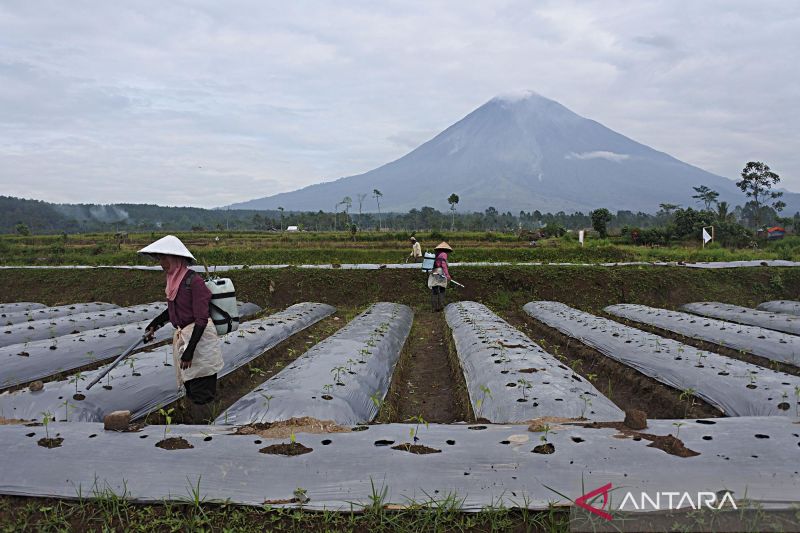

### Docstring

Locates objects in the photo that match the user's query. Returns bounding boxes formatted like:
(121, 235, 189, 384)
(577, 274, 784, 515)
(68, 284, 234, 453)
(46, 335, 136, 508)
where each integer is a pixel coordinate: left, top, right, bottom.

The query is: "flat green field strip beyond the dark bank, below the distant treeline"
(0, 231, 800, 266)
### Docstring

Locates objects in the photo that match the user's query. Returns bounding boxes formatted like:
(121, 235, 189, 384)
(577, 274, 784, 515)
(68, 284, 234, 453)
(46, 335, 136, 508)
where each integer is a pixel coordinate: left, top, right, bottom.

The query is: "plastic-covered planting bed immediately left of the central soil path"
(215, 302, 414, 424)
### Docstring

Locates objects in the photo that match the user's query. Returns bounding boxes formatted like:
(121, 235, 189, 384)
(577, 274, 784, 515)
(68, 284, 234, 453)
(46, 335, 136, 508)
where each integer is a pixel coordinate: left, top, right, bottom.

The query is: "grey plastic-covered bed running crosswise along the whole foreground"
(0, 417, 800, 511)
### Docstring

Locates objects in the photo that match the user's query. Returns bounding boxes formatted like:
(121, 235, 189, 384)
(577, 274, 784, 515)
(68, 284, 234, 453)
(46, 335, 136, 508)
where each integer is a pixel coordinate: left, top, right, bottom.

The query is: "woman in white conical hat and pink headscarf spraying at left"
(139, 235, 223, 422)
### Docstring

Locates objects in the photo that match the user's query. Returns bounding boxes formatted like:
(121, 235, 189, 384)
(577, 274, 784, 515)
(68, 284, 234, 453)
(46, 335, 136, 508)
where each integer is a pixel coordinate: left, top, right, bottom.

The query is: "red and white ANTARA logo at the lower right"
(575, 483, 738, 520)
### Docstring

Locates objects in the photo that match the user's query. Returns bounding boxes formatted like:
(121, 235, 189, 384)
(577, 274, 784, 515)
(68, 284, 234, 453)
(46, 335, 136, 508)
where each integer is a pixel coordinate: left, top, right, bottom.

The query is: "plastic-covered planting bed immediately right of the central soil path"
(445, 302, 625, 423)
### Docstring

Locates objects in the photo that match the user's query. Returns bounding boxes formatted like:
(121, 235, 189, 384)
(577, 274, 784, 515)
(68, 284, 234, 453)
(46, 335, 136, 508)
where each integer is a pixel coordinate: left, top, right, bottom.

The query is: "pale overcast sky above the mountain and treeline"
(0, 0, 800, 207)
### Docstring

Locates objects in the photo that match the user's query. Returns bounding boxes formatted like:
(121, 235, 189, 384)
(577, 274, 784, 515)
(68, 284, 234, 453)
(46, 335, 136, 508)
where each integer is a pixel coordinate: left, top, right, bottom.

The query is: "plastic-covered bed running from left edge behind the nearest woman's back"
(0, 303, 261, 388)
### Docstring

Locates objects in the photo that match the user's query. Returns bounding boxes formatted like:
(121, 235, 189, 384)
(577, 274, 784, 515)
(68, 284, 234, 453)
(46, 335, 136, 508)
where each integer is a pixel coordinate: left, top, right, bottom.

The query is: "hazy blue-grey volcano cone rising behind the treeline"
(231, 93, 800, 213)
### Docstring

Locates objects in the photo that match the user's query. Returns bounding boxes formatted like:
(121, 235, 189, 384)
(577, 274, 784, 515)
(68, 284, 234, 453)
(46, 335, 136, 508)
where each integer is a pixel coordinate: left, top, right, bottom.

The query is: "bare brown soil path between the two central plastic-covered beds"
(379, 309, 472, 424)
